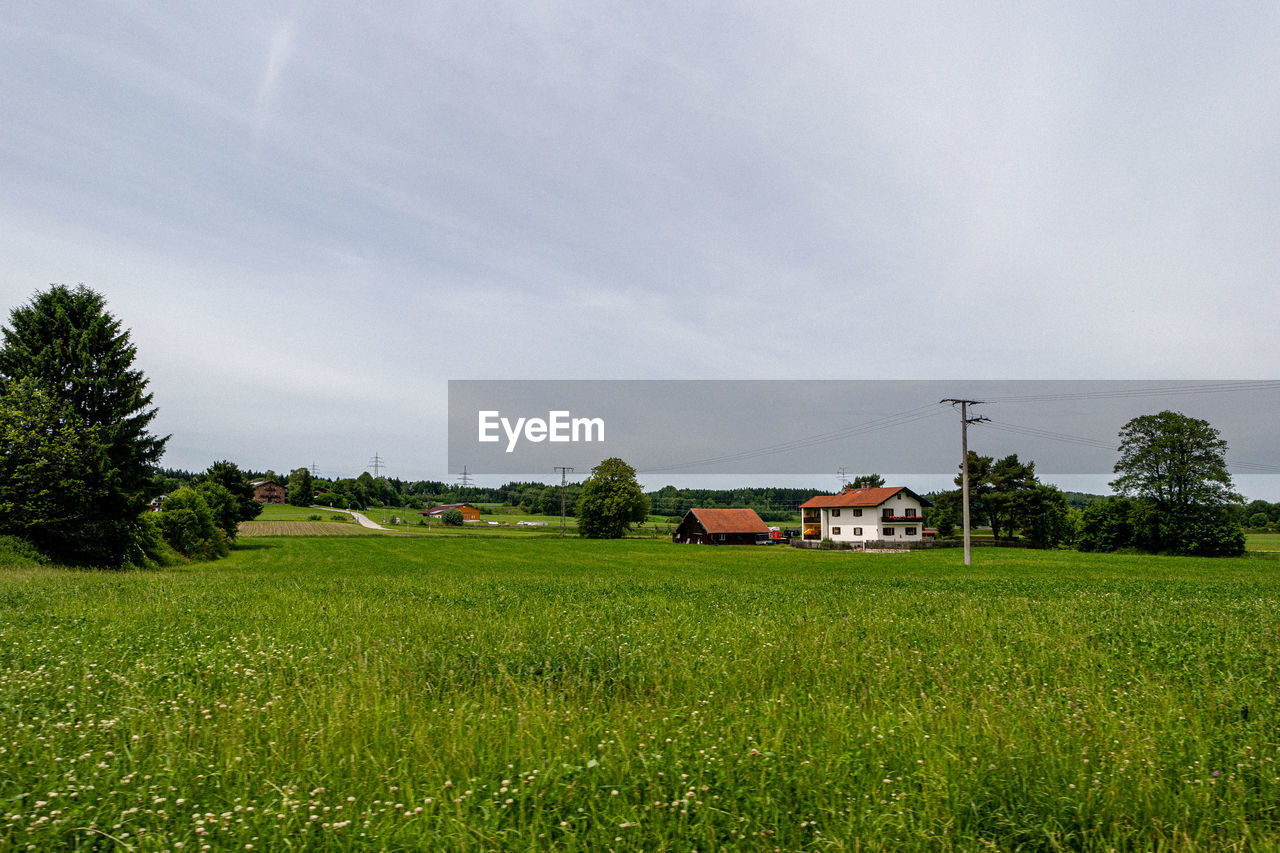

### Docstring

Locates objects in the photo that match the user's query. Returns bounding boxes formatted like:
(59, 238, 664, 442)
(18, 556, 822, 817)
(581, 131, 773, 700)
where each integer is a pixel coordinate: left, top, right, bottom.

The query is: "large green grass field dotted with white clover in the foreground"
(0, 535, 1280, 850)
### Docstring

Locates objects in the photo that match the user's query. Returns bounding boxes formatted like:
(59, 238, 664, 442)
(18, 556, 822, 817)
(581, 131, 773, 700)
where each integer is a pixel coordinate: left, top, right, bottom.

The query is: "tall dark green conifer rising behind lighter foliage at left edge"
(0, 284, 168, 567)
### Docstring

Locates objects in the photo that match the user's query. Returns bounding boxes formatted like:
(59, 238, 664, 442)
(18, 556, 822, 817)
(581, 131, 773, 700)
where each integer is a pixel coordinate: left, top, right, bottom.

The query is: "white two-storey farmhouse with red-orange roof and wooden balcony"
(800, 485, 933, 542)
